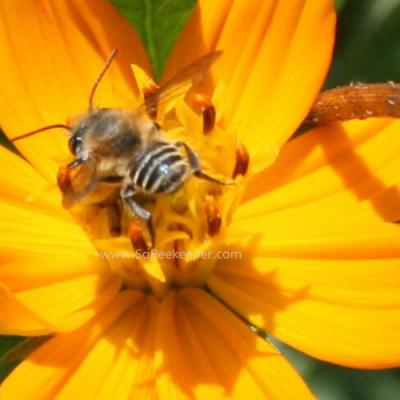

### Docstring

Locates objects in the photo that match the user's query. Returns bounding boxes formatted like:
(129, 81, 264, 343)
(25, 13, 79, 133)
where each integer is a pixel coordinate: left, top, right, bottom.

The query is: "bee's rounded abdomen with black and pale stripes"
(131, 142, 189, 194)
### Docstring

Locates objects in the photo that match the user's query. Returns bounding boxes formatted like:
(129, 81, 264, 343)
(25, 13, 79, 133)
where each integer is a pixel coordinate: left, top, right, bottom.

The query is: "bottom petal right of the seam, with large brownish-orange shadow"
(156, 289, 314, 400)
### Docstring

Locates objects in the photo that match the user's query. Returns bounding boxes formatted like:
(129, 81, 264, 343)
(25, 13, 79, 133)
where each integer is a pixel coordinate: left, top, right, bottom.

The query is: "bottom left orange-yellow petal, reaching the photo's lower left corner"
(0, 291, 157, 400)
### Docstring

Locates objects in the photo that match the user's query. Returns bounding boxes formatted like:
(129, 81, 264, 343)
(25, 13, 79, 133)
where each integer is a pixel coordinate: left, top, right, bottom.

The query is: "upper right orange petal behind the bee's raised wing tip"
(164, 0, 335, 166)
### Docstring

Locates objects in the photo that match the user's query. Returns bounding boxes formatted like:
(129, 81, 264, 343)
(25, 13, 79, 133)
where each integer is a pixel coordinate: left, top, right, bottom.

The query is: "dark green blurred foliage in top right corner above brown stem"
(327, 0, 400, 87)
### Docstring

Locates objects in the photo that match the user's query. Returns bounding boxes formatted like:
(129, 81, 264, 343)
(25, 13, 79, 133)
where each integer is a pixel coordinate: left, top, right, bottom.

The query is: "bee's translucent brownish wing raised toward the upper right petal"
(137, 51, 222, 112)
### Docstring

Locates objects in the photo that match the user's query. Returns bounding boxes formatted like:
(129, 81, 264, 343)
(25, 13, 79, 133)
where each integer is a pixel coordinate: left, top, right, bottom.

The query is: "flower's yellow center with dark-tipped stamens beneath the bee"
(61, 65, 248, 298)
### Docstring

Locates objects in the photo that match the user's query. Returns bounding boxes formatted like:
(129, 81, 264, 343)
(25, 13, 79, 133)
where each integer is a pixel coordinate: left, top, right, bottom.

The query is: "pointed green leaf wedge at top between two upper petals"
(111, 0, 196, 80)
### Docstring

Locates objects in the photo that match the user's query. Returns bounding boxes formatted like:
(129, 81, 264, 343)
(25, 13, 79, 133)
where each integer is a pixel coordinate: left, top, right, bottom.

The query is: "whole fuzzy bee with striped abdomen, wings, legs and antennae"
(13, 50, 227, 243)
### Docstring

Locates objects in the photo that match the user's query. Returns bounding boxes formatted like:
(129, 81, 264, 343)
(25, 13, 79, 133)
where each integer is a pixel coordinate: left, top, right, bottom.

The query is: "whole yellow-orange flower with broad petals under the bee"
(0, 0, 400, 399)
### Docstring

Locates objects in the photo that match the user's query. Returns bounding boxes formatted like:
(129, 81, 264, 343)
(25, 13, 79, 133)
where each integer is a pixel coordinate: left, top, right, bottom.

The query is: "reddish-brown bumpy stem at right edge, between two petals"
(305, 82, 400, 125)
